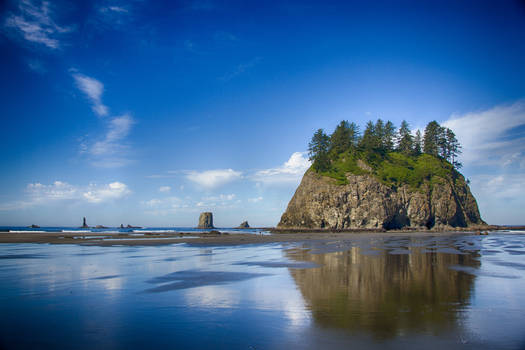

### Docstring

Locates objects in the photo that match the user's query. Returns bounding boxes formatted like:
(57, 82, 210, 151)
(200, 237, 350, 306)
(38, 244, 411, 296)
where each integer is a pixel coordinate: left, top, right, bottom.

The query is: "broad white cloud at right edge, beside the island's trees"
(443, 100, 525, 167)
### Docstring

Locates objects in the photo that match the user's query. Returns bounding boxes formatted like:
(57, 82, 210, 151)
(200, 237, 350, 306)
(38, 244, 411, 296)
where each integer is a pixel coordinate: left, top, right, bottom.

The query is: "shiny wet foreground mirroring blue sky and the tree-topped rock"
(0, 233, 525, 349)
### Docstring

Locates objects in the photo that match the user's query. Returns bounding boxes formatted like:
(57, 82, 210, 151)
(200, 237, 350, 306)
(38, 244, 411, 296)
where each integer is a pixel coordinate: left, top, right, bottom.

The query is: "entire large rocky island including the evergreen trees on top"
(277, 120, 486, 230)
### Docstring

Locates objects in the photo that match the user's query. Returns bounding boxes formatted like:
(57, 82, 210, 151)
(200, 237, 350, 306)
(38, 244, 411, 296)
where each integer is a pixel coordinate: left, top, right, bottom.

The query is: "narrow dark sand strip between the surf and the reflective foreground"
(0, 231, 488, 246)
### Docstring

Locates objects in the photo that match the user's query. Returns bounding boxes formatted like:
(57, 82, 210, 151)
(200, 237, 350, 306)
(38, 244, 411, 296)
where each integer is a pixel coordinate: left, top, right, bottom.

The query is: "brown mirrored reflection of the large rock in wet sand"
(288, 244, 480, 338)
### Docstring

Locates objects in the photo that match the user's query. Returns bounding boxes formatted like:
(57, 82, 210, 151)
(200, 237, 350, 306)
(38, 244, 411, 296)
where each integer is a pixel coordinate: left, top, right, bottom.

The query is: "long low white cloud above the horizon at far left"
(0, 181, 131, 211)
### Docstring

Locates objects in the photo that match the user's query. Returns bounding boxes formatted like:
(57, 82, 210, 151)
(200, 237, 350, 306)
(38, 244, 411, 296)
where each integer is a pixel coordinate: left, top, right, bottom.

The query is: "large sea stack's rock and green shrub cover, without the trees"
(277, 119, 485, 230)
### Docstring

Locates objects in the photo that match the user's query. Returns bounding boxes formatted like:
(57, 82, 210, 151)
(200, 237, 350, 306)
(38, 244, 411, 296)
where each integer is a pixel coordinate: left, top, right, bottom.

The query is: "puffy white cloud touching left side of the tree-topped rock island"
(252, 152, 311, 185)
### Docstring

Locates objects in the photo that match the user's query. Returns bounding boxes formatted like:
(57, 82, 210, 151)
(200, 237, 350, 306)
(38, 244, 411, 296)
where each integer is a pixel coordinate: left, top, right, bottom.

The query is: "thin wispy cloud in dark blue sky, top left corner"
(5, 0, 72, 49)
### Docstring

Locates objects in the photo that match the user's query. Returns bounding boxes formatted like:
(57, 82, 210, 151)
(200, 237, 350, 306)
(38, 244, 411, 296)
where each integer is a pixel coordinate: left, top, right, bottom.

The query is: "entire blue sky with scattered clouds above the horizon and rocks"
(0, 0, 525, 226)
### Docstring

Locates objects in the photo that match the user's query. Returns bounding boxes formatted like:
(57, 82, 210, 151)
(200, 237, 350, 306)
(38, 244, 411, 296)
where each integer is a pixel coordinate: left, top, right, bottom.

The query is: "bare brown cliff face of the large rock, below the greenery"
(278, 169, 485, 229)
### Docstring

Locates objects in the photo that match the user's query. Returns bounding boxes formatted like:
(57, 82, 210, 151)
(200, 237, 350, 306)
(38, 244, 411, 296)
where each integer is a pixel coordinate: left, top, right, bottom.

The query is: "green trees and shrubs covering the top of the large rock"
(308, 119, 461, 189)
